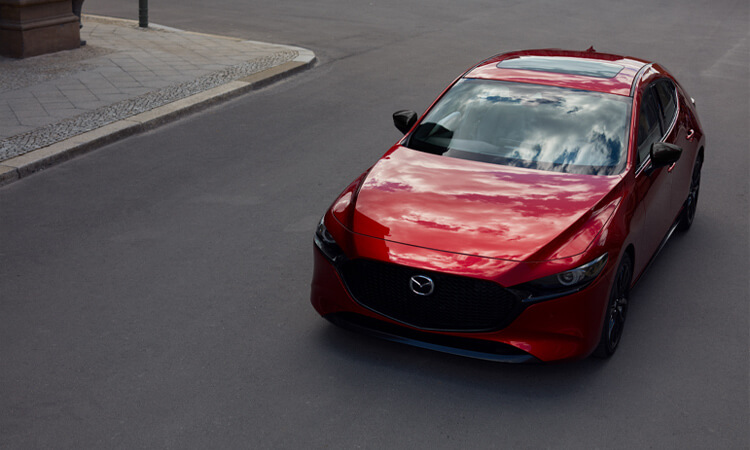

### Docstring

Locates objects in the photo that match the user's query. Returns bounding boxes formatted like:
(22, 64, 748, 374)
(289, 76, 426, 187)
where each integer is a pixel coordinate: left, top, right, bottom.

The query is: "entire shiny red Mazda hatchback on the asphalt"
(311, 49, 705, 362)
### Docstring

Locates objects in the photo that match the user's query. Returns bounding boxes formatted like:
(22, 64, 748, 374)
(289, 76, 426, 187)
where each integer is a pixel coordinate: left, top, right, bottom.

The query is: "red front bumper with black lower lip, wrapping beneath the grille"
(311, 243, 613, 362)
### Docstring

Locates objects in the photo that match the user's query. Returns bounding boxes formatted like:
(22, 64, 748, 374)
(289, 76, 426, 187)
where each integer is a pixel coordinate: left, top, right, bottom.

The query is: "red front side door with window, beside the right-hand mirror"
(635, 83, 676, 267)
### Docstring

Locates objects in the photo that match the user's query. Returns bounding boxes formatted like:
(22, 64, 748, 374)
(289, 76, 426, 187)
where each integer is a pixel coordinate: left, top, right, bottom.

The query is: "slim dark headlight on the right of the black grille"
(508, 253, 607, 302)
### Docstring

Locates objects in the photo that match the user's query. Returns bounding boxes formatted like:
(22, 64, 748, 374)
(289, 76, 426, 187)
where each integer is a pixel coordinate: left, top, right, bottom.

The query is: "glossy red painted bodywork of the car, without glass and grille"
(311, 50, 705, 361)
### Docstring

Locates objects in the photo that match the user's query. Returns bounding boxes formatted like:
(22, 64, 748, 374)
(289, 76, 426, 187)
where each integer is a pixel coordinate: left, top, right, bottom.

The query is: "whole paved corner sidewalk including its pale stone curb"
(0, 15, 315, 185)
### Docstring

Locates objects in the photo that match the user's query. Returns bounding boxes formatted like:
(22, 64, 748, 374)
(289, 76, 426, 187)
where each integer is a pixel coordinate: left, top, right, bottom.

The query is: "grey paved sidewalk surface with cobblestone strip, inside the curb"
(0, 15, 312, 162)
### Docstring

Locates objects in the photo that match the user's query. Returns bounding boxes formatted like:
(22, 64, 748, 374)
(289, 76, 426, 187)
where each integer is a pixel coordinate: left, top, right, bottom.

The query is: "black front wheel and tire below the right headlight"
(593, 253, 633, 358)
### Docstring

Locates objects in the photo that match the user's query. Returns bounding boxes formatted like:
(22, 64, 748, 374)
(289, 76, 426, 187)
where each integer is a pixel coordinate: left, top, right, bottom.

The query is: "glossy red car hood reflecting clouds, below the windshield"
(350, 147, 621, 261)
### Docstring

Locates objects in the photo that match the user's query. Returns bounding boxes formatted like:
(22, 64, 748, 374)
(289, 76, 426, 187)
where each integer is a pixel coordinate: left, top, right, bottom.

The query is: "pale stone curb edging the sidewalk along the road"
(0, 36, 316, 186)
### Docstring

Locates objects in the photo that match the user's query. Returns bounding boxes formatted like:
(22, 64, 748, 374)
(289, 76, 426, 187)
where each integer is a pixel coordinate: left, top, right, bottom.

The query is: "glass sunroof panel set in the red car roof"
(497, 56, 623, 78)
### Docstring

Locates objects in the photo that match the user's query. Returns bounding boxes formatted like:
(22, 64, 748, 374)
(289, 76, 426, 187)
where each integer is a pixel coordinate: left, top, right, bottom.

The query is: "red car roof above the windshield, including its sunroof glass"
(464, 49, 649, 96)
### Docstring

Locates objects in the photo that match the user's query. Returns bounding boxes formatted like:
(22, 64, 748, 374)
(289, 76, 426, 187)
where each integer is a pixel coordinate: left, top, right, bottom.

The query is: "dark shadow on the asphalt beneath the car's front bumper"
(315, 324, 614, 398)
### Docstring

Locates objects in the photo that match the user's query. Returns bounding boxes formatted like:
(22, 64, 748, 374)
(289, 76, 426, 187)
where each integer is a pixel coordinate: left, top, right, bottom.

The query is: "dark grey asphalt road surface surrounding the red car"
(0, 0, 750, 449)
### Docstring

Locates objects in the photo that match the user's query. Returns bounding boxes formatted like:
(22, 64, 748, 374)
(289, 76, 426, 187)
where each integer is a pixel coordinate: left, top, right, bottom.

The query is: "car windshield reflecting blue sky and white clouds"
(406, 79, 630, 175)
